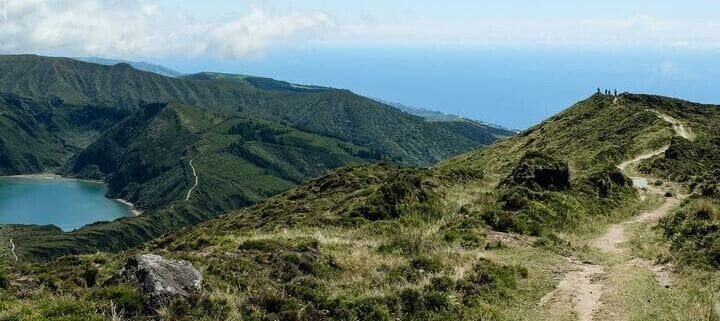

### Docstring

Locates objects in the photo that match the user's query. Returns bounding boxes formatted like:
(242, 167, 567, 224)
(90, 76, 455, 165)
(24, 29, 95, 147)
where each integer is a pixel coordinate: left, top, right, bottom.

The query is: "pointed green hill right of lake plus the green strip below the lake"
(3, 104, 380, 258)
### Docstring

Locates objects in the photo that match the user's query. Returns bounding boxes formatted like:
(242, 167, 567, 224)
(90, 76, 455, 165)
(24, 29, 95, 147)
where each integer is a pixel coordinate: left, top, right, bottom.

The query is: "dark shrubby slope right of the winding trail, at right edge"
(624, 96, 720, 269)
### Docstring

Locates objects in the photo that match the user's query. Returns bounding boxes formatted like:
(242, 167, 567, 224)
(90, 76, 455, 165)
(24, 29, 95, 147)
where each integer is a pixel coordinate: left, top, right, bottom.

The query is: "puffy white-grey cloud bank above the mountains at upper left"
(0, 0, 334, 58)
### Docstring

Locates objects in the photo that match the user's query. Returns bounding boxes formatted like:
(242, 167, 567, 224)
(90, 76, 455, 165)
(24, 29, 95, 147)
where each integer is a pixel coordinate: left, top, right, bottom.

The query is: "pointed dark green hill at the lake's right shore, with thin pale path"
(64, 100, 375, 212)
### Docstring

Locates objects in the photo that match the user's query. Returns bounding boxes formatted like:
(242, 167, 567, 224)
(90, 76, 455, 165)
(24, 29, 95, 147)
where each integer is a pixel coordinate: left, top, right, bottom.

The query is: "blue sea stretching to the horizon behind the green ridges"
(155, 45, 720, 129)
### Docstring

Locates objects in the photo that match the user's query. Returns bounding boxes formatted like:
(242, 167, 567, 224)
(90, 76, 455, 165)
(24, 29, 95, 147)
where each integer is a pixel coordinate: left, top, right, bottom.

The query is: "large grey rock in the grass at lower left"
(106, 254, 202, 307)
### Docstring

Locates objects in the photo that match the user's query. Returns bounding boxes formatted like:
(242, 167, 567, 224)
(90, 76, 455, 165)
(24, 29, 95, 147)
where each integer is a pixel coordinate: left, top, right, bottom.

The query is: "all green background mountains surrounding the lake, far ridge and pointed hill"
(0, 55, 504, 258)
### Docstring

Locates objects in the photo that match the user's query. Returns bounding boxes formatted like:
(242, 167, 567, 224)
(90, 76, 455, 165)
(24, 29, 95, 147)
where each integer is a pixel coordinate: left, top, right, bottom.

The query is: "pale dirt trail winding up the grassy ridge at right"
(539, 110, 692, 321)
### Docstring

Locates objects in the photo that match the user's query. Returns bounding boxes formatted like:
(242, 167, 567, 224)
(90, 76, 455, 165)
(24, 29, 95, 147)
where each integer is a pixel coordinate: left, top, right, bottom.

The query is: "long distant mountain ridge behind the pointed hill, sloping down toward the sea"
(0, 55, 506, 166)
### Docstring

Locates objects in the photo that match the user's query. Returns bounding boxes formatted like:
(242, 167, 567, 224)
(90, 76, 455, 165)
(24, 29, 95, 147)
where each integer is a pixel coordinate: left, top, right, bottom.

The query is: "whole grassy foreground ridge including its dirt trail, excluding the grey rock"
(0, 94, 720, 320)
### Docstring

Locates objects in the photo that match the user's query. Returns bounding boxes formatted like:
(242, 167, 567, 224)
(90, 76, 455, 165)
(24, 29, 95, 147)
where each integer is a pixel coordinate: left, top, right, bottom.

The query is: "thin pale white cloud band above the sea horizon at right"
(323, 15, 720, 47)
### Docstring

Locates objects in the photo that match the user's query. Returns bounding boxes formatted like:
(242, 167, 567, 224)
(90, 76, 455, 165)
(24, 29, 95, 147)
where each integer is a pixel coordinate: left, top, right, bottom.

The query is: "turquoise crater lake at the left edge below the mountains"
(0, 177, 132, 231)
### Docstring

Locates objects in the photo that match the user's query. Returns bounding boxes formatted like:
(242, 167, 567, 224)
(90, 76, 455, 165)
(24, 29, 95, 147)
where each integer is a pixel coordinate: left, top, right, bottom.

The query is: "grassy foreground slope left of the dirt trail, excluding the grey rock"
(7, 92, 720, 320)
